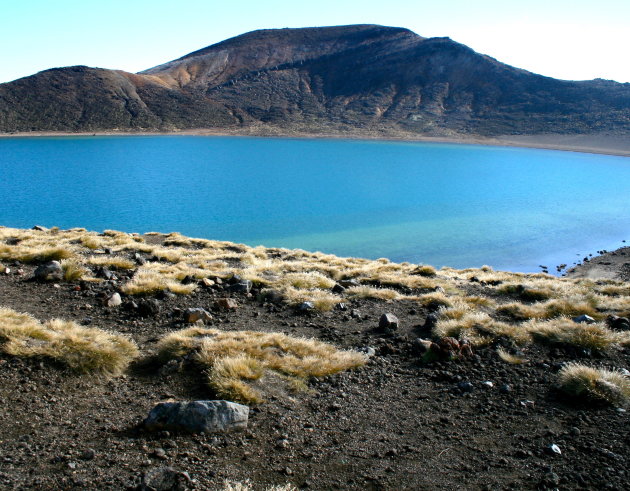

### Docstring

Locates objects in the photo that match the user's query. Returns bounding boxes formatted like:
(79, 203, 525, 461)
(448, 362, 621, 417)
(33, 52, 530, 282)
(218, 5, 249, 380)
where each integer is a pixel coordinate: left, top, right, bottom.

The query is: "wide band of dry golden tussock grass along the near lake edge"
(0, 227, 630, 342)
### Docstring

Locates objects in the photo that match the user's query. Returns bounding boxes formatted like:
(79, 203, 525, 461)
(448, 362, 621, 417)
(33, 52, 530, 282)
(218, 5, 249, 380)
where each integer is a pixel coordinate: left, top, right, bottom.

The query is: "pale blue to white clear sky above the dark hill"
(0, 0, 630, 82)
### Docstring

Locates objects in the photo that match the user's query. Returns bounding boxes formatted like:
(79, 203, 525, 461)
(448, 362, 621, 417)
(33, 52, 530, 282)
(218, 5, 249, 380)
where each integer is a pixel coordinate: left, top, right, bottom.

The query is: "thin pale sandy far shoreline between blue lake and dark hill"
(0, 128, 630, 157)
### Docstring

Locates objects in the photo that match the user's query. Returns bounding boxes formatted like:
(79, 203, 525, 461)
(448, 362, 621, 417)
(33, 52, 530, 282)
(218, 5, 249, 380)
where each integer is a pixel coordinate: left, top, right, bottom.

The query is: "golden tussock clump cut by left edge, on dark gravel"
(0, 308, 138, 375)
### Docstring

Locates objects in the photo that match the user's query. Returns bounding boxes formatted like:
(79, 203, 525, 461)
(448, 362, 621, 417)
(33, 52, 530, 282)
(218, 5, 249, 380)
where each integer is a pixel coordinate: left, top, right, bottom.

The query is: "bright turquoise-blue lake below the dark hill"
(0, 136, 630, 271)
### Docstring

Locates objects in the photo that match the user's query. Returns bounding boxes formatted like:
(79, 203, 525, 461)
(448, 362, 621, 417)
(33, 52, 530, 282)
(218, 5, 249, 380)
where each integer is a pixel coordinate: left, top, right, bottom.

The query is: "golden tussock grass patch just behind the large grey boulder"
(158, 327, 367, 403)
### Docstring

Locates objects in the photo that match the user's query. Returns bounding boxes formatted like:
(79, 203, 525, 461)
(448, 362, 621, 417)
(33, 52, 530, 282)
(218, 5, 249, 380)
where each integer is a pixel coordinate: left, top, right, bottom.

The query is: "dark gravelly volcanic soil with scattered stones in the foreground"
(0, 229, 630, 490)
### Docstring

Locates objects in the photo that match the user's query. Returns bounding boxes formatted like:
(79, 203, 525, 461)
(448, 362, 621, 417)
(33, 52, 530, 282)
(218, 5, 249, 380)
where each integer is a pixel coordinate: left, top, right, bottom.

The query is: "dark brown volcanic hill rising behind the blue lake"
(0, 25, 630, 136)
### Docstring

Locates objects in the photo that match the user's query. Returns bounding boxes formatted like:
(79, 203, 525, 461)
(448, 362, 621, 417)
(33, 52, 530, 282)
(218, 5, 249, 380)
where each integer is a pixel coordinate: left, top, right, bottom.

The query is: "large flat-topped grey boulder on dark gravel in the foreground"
(144, 401, 249, 433)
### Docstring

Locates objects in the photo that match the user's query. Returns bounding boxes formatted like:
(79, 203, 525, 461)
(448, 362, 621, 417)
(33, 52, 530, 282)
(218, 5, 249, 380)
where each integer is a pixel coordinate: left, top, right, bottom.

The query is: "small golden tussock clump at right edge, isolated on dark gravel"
(558, 363, 630, 406)
